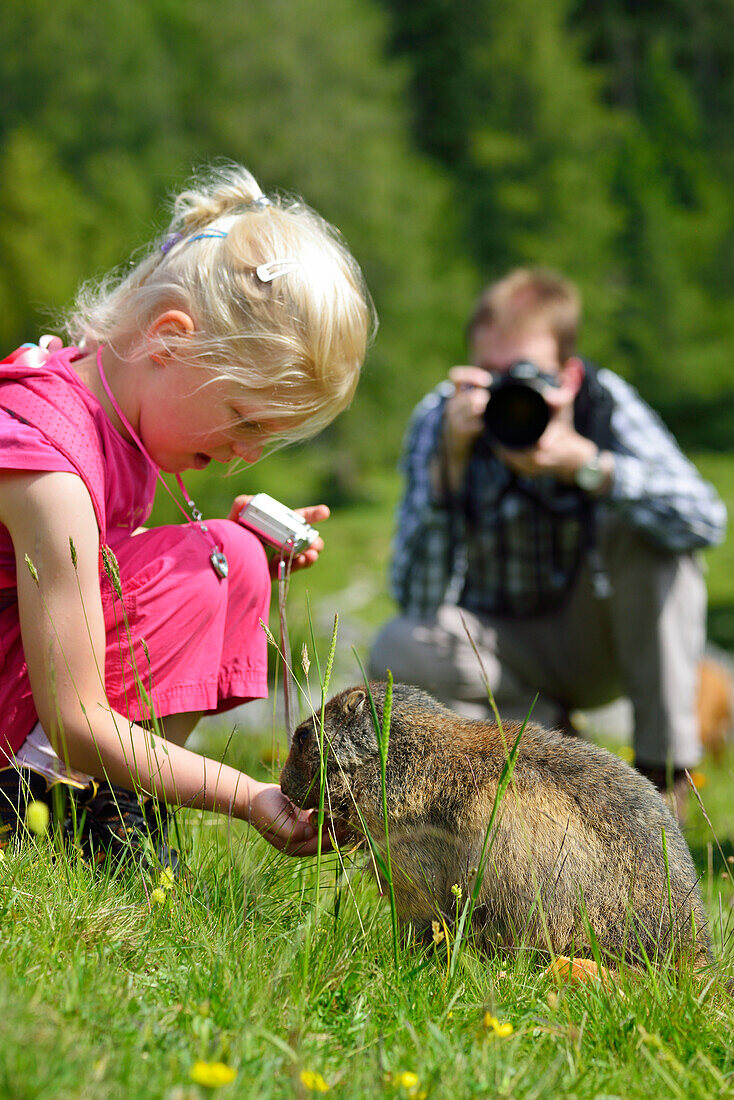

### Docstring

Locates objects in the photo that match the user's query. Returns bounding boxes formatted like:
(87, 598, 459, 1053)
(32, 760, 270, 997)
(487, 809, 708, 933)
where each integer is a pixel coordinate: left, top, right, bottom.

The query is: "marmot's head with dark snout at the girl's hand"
(281, 684, 384, 820)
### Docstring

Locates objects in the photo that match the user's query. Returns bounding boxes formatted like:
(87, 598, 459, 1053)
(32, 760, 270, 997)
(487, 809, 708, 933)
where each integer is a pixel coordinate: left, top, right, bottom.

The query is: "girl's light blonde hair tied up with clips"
(66, 165, 376, 441)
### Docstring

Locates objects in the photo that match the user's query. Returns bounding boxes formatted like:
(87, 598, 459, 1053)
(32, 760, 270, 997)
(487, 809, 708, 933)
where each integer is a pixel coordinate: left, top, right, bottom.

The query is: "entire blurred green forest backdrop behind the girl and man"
(0, 0, 734, 639)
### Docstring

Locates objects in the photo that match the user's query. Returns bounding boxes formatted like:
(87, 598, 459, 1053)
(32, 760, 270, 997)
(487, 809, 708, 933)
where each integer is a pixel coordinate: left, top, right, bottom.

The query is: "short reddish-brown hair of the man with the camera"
(467, 267, 581, 363)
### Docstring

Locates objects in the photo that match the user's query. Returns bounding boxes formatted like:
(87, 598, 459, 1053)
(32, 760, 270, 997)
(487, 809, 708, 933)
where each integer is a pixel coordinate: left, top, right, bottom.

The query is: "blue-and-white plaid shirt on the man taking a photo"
(391, 370, 726, 617)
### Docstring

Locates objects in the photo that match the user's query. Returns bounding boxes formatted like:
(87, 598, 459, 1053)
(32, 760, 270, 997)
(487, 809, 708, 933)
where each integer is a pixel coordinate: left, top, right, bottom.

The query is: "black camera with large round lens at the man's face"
(484, 360, 559, 451)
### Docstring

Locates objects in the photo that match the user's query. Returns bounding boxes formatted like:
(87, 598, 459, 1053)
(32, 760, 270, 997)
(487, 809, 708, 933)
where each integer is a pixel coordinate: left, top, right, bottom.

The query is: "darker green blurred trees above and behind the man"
(383, 0, 734, 448)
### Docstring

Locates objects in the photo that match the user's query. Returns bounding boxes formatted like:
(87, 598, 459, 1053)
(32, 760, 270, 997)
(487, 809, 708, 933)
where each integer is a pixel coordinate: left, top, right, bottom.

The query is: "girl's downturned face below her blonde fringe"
(139, 360, 276, 473)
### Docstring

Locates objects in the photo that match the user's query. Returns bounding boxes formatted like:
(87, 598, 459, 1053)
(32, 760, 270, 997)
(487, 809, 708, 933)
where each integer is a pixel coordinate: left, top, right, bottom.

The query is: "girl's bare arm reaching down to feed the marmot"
(0, 471, 317, 855)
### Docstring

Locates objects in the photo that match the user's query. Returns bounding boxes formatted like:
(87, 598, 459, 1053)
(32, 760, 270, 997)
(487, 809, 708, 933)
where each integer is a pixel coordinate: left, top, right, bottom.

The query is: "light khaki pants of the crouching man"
(370, 521, 706, 768)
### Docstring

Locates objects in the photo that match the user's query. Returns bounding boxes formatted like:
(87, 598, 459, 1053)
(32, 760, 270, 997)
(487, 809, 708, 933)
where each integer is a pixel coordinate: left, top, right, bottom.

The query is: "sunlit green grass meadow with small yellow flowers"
(0, 457, 734, 1100)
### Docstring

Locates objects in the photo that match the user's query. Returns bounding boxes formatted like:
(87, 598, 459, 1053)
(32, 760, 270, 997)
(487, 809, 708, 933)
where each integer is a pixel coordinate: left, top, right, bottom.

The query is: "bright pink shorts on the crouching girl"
(102, 519, 271, 721)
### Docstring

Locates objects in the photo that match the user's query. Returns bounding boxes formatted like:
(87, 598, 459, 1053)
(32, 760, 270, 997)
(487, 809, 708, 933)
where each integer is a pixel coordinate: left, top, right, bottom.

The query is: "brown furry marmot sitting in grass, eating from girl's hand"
(281, 682, 711, 966)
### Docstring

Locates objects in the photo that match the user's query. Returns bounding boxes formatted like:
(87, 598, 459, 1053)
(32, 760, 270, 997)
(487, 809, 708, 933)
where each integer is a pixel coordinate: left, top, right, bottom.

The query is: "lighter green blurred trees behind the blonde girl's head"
(0, 0, 476, 486)
